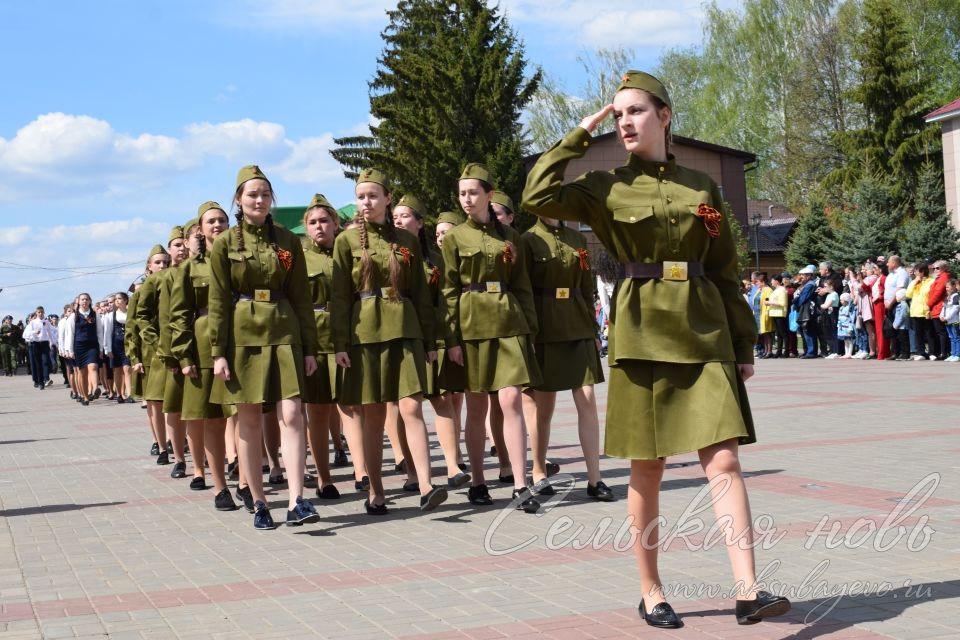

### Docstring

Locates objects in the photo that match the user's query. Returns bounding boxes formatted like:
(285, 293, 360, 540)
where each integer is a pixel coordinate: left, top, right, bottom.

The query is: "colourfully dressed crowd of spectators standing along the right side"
(743, 255, 960, 362)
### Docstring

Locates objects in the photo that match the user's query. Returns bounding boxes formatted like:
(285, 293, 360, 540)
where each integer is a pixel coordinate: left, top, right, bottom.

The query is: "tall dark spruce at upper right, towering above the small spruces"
(826, 0, 940, 200)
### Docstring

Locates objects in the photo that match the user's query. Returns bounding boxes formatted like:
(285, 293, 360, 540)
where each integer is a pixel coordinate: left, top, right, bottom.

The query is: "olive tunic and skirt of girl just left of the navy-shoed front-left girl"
(169, 256, 236, 420)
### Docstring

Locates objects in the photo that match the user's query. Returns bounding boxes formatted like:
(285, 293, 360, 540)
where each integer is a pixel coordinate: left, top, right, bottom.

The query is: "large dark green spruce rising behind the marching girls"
(331, 0, 541, 216)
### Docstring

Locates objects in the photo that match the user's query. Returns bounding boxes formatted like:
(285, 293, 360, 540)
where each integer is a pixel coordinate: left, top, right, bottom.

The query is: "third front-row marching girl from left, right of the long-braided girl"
(443, 163, 540, 513)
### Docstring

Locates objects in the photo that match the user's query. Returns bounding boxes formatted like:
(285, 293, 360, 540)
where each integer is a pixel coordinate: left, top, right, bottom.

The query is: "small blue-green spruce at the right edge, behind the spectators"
(901, 163, 960, 262)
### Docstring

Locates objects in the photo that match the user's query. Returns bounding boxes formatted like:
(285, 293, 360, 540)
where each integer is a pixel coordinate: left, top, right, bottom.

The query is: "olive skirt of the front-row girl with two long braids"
(338, 338, 427, 405)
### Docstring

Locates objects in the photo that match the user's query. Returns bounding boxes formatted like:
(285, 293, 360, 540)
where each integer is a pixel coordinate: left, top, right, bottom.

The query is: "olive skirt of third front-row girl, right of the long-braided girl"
(463, 335, 542, 393)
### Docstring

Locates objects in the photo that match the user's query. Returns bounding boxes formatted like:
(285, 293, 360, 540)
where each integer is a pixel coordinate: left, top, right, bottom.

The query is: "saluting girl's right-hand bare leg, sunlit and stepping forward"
(699, 439, 757, 600)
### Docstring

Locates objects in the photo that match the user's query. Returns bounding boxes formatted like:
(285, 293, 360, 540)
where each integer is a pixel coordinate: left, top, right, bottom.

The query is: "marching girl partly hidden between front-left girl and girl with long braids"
(303, 193, 350, 500)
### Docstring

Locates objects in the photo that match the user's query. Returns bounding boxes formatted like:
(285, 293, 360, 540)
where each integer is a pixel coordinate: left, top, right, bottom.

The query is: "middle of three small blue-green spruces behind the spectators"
(827, 175, 904, 264)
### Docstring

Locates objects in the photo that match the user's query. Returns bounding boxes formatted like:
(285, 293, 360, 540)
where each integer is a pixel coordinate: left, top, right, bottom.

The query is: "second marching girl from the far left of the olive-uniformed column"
(136, 226, 187, 478)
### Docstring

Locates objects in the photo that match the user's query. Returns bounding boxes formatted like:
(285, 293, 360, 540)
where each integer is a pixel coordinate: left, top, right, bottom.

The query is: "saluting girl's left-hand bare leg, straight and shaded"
(627, 459, 666, 611)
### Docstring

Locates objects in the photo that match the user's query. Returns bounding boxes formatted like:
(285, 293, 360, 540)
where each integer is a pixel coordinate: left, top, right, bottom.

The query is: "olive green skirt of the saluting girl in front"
(604, 360, 757, 460)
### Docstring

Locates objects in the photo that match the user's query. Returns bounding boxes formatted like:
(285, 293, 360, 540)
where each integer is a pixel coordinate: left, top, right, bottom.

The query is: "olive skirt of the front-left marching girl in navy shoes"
(210, 344, 303, 404)
